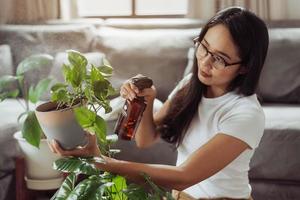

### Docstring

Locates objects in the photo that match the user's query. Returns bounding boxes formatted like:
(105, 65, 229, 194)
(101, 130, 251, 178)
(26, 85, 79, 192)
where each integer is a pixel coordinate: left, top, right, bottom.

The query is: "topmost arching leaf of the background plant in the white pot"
(16, 54, 53, 76)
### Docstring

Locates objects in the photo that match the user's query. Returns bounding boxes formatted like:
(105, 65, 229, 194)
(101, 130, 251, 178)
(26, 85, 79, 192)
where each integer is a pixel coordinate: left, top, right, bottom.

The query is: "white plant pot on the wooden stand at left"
(14, 131, 63, 190)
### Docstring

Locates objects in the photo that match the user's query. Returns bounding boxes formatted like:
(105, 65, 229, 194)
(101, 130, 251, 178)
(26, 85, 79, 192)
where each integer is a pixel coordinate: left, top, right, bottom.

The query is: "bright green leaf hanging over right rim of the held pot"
(74, 107, 96, 128)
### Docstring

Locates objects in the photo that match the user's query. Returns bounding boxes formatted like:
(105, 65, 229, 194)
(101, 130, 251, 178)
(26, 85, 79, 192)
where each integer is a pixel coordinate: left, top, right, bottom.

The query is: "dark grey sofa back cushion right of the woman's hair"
(258, 28, 300, 103)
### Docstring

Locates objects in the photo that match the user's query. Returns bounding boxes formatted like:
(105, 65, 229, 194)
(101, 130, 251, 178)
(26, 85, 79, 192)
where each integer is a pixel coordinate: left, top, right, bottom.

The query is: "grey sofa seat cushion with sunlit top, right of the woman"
(249, 105, 300, 181)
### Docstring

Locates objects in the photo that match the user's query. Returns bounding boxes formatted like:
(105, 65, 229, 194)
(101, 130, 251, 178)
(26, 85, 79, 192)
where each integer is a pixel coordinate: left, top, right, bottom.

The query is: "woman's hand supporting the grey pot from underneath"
(48, 133, 101, 156)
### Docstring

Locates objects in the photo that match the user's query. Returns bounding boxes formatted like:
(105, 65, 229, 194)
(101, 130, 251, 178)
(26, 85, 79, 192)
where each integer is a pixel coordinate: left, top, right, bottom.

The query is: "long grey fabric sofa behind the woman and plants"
(0, 19, 300, 200)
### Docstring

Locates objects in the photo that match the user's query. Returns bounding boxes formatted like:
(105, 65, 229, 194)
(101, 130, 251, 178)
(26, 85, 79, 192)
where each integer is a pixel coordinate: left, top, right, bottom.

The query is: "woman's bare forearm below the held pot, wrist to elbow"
(96, 157, 190, 190)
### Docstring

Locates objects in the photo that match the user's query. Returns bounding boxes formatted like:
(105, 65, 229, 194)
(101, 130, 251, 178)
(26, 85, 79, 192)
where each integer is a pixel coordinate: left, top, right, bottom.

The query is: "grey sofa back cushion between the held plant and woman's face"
(92, 27, 199, 100)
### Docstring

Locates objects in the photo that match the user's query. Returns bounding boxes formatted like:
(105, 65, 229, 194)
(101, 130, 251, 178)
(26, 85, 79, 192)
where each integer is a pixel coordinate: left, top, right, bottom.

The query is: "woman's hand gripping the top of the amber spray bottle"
(120, 76, 157, 104)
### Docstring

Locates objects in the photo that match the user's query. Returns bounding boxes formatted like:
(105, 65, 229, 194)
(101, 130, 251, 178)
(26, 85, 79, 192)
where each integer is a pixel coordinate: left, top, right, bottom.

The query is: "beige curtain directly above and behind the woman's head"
(187, 0, 287, 21)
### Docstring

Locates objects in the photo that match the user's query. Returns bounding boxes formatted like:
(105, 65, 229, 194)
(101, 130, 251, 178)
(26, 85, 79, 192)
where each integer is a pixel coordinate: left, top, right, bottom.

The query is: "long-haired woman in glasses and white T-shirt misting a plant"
(51, 7, 269, 199)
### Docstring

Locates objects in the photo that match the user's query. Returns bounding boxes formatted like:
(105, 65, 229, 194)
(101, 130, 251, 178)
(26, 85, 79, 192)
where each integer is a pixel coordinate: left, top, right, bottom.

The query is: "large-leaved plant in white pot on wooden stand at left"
(0, 54, 62, 188)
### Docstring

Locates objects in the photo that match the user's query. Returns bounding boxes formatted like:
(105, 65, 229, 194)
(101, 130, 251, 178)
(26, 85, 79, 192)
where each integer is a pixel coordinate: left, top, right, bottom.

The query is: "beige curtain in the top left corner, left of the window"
(0, 0, 59, 24)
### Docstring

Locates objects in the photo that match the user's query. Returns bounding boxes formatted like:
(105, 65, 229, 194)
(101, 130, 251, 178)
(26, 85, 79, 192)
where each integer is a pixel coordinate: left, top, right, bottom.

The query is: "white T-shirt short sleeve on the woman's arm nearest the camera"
(218, 105, 265, 149)
